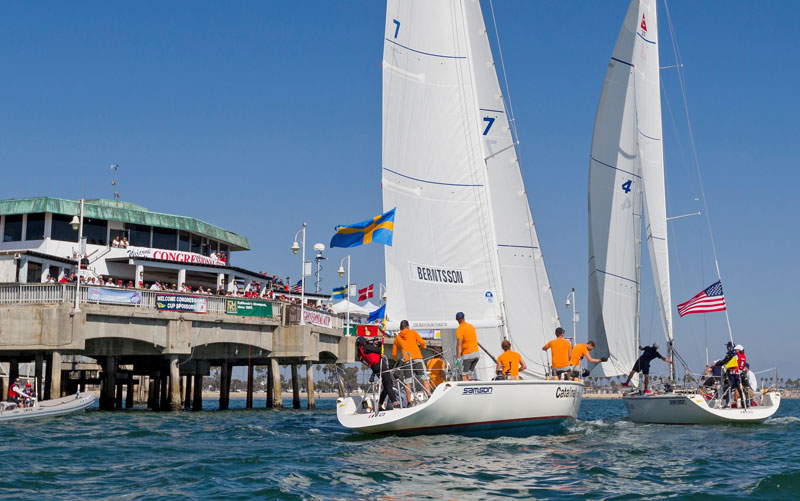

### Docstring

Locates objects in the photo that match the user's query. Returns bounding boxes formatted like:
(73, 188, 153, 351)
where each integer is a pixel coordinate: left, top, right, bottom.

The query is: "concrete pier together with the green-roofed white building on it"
(0, 197, 355, 410)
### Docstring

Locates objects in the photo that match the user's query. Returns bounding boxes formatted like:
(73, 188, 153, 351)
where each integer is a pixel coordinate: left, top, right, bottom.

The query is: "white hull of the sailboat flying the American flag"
(622, 392, 781, 424)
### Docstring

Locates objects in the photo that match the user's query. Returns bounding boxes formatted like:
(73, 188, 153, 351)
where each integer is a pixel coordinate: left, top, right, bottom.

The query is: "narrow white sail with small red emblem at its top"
(634, 0, 672, 341)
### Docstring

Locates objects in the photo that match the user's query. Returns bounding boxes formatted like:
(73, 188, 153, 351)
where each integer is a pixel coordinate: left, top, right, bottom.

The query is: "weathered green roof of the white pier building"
(0, 197, 250, 250)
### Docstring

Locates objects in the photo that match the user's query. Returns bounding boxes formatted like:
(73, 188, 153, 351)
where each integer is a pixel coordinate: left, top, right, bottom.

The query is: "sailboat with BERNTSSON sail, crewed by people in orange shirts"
(337, 0, 583, 433)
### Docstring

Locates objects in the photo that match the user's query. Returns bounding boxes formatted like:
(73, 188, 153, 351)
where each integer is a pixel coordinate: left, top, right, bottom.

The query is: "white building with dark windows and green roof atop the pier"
(0, 197, 267, 290)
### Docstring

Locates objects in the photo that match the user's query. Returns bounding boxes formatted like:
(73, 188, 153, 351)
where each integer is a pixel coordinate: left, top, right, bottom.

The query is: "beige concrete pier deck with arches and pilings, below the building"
(0, 283, 355, 411)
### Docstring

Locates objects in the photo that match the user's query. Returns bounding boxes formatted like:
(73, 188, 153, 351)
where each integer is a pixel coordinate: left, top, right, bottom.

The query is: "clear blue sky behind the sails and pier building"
(0, 0, 800, 377)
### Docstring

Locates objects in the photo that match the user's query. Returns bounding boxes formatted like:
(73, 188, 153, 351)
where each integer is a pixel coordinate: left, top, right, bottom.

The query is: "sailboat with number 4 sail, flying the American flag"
(589, 0, 780, 424)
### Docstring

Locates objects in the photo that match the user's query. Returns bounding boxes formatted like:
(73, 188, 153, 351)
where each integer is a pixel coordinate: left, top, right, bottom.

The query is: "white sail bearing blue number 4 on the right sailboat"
(589, 0, 642, 376)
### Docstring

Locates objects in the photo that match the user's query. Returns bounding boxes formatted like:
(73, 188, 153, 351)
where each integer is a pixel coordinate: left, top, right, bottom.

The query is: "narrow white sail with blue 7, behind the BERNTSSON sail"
(465, 1, 559, 375)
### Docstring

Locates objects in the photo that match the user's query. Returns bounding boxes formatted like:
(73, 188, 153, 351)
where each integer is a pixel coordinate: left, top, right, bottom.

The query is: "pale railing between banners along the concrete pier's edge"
(0, 283, 290, 327)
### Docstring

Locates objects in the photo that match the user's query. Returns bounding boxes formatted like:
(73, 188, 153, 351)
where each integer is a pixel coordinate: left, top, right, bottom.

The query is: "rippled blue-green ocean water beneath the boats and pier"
(0, 400, 800, 499)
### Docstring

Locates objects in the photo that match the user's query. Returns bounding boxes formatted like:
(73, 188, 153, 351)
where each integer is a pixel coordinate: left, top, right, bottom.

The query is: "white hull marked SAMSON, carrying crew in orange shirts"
(336, 380, 583, 434)
